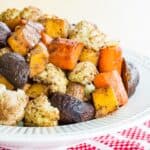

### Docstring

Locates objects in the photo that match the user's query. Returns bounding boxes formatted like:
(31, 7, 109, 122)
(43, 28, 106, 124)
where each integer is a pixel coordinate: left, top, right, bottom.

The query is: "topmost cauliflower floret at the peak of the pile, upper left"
(20, 6, 43, 21)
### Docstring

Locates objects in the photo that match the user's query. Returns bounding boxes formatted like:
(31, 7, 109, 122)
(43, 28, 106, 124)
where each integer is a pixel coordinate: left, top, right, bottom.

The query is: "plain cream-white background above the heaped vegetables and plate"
(0, 0, 150, 56)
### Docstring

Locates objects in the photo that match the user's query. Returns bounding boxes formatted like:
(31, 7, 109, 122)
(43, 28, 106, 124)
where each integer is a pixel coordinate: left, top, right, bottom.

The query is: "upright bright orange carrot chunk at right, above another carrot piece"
(99, 45, 122, 74)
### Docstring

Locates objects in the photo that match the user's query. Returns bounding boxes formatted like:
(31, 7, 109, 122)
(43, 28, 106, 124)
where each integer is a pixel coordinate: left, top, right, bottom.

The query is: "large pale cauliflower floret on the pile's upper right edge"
(69, 21, 106, 51)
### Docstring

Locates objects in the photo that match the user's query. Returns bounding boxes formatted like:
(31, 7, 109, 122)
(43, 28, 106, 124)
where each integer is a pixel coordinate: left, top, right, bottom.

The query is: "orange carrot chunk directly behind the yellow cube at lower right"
(94, 70, 128, 106)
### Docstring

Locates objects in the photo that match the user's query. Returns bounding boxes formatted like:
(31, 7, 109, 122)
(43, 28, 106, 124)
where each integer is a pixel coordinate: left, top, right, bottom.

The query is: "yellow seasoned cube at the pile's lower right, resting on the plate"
(93, 87, 119, 118)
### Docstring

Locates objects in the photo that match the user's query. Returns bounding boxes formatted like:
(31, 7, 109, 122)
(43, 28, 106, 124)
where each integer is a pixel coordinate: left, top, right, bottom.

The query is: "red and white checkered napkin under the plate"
(67, 120, 150, 150)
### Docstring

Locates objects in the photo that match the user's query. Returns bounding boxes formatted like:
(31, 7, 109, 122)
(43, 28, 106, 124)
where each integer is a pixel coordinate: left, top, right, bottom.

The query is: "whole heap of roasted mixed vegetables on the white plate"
(0, 7, 139, 127)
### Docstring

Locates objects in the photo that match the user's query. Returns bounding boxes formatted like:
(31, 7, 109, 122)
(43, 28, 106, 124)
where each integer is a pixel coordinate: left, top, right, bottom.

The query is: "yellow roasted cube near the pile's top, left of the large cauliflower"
(41, 18, 69, 38)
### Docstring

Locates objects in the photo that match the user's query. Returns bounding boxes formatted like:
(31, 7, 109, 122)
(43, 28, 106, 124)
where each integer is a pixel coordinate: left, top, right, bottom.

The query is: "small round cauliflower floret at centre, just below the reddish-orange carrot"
(69, 61, 98, 85)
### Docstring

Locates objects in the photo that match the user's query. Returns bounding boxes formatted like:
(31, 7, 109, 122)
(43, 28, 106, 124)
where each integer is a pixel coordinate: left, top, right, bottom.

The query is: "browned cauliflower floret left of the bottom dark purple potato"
(25, 95, 59, 127)
